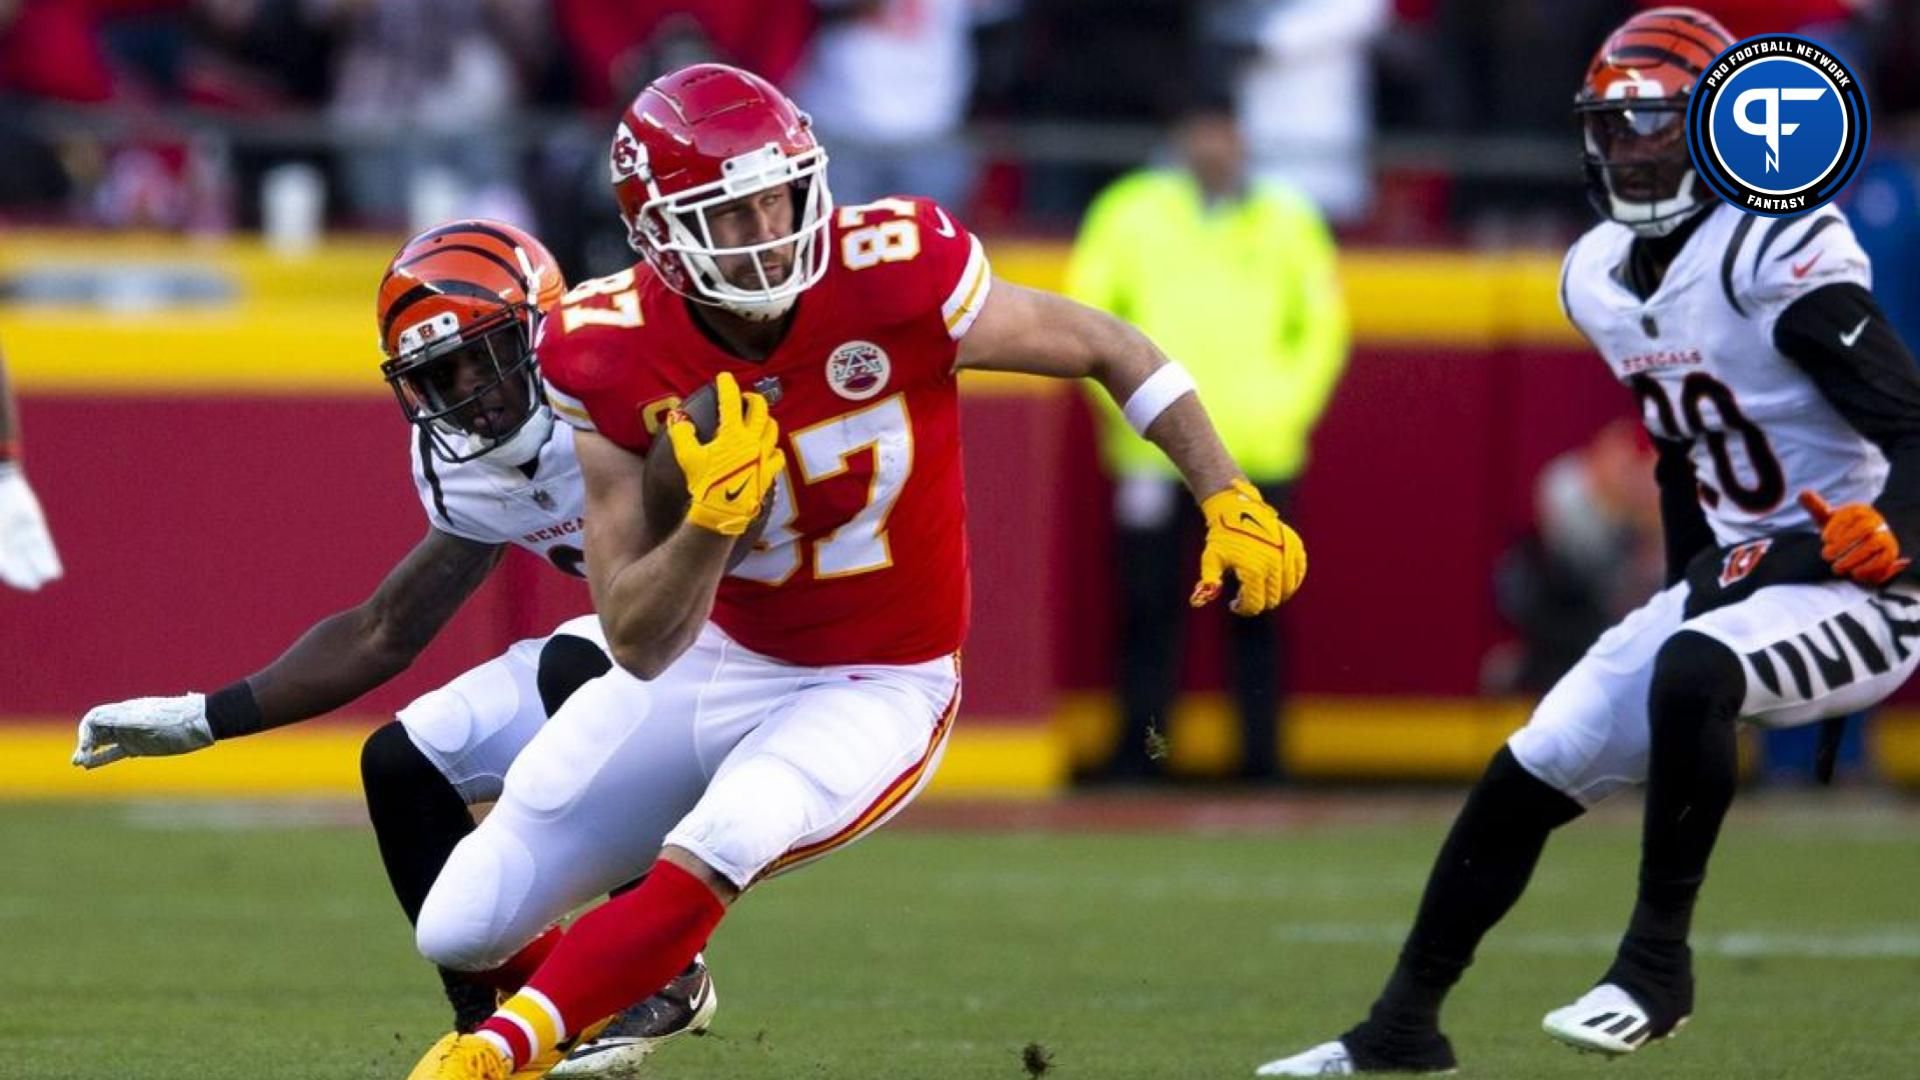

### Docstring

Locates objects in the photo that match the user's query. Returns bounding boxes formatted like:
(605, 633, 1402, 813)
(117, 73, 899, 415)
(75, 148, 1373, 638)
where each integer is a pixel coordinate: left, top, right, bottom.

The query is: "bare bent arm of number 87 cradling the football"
(574, 430, 733, 678)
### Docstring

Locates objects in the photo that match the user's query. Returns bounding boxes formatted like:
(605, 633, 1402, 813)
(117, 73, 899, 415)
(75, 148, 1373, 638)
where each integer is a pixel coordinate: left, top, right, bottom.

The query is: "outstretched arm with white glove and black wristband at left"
(73, 528, 503, 769)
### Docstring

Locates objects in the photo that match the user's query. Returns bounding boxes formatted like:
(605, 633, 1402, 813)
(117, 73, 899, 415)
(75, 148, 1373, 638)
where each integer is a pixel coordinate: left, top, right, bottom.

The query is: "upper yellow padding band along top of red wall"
(0, 231, 1578, 396)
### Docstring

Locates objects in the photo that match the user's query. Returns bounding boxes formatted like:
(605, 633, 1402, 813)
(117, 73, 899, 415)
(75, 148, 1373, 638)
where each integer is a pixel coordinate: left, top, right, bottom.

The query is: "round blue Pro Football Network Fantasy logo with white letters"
(1686, 35, 1868, 217)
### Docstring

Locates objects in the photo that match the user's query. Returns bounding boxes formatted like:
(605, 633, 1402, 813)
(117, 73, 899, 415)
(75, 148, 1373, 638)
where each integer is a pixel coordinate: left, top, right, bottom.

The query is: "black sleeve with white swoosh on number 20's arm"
(1774, 284, 1920, 552)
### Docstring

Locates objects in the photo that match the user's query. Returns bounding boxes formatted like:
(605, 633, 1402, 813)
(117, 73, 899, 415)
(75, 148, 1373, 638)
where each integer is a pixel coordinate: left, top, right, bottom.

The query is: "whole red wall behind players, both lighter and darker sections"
(11, 340, 1843, 723)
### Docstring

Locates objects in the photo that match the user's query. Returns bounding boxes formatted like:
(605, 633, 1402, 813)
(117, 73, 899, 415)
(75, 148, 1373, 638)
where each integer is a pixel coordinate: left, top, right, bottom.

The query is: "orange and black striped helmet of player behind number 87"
(378, 219, 566, 461)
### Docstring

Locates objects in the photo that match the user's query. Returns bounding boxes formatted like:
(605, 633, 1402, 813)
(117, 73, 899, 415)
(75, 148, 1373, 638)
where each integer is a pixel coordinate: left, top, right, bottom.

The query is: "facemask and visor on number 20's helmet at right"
(1574, 96, 1707, 238)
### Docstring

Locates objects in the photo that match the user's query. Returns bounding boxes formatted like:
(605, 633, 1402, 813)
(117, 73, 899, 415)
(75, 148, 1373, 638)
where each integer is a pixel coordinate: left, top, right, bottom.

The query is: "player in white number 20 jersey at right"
(1258, 8, 1920, 1076)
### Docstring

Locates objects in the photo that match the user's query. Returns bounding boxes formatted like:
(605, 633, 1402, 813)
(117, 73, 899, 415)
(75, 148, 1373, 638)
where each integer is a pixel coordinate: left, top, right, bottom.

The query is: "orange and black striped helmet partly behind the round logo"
(1574, 8, 1734, 236)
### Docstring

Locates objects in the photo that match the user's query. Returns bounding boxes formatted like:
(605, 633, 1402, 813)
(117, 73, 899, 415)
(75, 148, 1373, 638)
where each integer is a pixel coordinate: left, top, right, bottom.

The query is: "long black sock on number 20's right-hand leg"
(1607, 630, 1747, 1026)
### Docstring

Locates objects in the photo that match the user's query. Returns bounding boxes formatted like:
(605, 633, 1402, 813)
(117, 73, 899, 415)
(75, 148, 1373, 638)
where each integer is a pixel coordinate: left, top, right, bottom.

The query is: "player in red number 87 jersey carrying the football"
(403, 63, 1306, 1078)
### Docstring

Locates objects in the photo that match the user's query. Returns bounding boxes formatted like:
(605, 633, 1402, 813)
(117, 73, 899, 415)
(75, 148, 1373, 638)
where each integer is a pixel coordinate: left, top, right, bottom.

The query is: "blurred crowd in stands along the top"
(0, 0, 1920, 269)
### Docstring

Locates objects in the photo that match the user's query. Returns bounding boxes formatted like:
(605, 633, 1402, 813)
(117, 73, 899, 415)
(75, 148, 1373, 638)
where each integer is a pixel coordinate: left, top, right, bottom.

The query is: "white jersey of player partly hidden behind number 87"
(413, 411, 586, 577)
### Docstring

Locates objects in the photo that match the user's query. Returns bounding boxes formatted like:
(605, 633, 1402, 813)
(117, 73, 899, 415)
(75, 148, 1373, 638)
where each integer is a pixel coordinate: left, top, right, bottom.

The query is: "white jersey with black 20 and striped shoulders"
(1561, 204, 1887, 546)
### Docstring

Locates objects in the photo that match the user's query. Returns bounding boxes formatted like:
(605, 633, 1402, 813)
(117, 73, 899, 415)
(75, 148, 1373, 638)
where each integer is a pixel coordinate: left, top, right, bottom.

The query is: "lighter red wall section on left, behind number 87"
(0, 396, 1066, 721)
